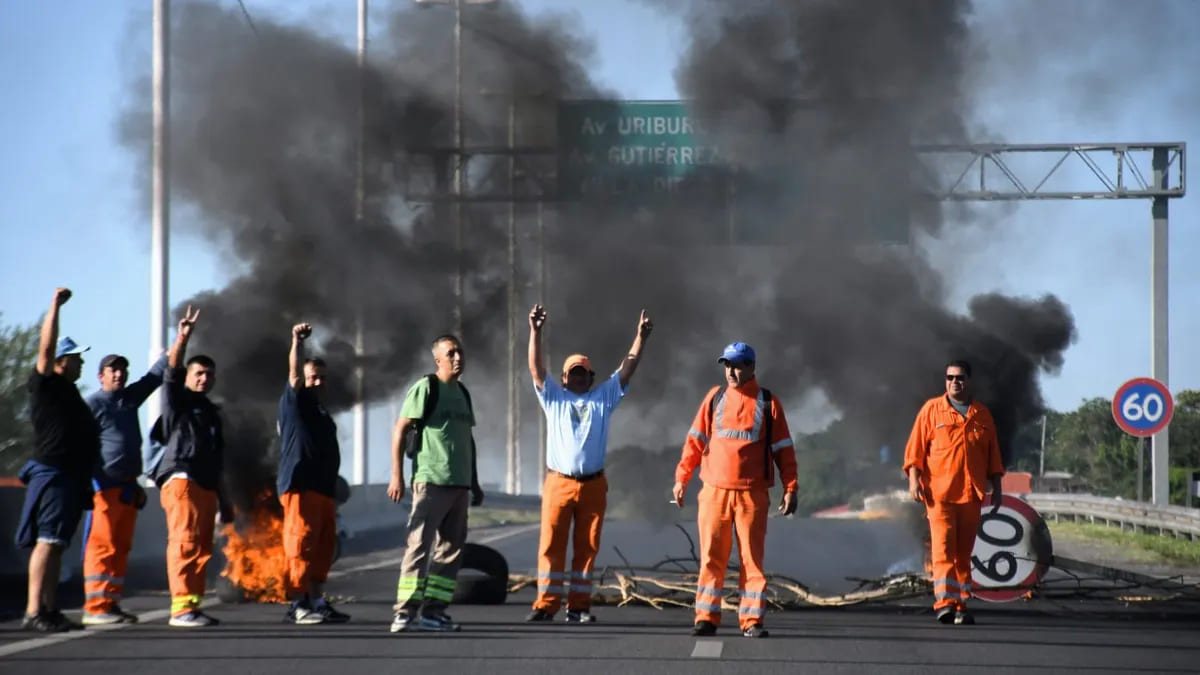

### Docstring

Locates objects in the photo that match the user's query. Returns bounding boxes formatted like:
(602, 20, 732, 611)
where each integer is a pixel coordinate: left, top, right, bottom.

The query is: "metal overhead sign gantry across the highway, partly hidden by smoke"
(402, 138, 1187, 504)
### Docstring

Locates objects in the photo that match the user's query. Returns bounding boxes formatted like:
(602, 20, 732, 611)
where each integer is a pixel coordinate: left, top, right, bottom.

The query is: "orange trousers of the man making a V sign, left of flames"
(158, 478, 217, 616)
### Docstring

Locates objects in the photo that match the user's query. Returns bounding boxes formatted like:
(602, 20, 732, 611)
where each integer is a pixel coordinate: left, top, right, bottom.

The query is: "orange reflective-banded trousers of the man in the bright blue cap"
(696, 485, 770, 629)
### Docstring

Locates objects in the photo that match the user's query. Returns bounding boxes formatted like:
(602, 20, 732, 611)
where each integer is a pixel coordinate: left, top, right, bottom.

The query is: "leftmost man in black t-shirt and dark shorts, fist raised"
(16, 288, 100, 633)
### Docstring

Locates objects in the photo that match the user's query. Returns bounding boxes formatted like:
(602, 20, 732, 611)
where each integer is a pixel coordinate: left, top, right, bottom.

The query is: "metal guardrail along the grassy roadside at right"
(1025, 492, 1200, 540)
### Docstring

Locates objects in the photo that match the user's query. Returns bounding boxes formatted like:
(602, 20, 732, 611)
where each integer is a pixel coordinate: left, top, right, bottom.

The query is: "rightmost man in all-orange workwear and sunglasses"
(904, 360, 1004, 625)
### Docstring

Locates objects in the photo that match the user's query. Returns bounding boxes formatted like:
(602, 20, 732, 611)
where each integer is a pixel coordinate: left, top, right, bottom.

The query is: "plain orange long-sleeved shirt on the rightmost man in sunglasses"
(904, 395, 1004, 503)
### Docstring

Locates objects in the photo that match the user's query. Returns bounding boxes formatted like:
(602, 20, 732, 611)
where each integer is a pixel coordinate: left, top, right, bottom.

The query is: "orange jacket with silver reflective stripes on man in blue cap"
(676, 380, 796, 492)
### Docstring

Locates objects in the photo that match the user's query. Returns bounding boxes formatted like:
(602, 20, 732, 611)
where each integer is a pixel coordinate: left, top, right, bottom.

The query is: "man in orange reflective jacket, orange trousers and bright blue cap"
(672, 342, 797, 638)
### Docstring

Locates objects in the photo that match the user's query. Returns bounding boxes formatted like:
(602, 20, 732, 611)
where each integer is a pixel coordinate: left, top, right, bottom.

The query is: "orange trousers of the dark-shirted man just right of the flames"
(280, 490, 337, 596)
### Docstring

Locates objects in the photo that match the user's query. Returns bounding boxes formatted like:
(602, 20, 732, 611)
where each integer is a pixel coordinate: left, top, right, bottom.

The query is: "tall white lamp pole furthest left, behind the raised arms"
(146, 0, 170, 441)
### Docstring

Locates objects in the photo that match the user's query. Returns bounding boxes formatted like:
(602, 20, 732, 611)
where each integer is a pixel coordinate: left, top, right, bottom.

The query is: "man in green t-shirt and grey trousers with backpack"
(388, 335, 484, 633)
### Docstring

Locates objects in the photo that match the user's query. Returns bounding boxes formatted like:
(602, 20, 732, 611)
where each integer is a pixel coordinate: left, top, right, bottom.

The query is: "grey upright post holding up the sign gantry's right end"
(1150, 148, 1170, 506)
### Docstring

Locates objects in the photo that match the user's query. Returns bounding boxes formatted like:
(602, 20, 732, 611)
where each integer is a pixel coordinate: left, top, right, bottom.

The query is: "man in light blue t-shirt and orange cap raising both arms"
(526, 305, 654, 623)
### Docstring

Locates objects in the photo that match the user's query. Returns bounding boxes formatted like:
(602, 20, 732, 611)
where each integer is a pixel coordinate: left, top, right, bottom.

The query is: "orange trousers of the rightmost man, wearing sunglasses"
(925, 500, 983, 610)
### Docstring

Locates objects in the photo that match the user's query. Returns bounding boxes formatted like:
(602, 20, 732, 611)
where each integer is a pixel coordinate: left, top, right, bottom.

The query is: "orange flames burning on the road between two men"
(221, 491, 288, 603)
